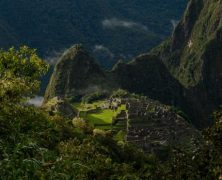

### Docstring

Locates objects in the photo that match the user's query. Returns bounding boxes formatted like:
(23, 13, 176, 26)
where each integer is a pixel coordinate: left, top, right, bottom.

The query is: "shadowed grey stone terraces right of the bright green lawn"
(126, 99, 201, 152)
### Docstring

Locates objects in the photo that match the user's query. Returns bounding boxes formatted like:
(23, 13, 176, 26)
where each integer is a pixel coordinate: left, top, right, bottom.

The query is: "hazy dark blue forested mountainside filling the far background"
(0, 0, 186, 67)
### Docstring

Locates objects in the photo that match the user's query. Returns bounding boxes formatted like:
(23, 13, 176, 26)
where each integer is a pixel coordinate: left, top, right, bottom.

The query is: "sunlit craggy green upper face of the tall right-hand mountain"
(166, 0, 222, 87)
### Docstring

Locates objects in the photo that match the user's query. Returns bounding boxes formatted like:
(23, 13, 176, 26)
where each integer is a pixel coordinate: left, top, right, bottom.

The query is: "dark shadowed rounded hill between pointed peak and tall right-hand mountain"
(112, 54, 183, 104)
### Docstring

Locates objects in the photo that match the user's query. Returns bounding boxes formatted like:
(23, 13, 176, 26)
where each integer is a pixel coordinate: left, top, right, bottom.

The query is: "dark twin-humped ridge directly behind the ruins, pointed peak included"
(45, 44, 183, 103)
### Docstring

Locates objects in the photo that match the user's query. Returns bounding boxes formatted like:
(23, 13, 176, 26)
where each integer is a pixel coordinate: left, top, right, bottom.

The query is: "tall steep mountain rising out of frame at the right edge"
(162, 0, 222, 124)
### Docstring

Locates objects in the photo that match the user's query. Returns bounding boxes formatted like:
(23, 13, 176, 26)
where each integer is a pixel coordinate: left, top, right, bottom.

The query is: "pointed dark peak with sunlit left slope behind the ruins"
(45, 45, 113, 101)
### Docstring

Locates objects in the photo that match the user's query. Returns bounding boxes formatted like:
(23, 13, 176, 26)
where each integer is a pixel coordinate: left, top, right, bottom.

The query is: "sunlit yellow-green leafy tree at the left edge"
(0, 46, 48, 105)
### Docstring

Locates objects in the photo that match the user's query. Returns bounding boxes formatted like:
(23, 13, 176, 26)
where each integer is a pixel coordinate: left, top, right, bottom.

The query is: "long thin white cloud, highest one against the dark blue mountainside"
(102, 18, 148, 31)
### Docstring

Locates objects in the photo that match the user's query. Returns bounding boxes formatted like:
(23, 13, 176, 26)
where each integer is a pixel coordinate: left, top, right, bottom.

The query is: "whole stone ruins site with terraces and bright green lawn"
(73, 98, 202, 152)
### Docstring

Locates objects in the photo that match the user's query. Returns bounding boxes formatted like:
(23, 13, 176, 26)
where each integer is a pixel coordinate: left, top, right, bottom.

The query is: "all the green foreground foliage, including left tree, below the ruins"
(0, 47, 222, 179)
